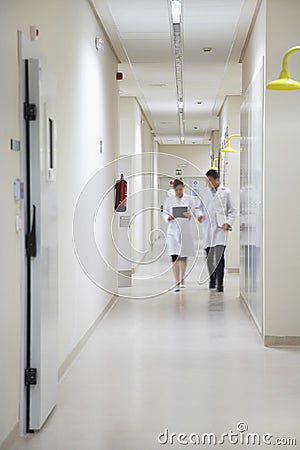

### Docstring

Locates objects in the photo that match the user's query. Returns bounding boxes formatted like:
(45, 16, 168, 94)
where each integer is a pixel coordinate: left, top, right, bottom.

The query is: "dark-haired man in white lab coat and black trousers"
(197, 169, 236, 292)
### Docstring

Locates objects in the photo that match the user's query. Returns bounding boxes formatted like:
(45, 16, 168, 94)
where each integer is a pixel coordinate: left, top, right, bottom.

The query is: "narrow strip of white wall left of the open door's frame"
(0, 2, 20, 444)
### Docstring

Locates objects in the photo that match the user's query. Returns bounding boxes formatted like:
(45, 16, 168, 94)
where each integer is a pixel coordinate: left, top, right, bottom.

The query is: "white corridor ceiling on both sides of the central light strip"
(93, 0, 258, 144)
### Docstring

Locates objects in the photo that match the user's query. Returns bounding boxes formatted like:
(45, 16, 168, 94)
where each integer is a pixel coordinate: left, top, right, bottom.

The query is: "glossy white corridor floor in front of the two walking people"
(9, 244, 300, 450)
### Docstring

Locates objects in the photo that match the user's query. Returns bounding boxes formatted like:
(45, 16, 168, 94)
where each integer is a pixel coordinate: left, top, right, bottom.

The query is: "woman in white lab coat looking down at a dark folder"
(164, 180, 195, 292)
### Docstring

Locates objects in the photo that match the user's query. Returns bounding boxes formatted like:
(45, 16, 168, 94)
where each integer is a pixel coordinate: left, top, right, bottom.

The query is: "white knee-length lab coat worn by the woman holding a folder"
(163, 195, 195, 257)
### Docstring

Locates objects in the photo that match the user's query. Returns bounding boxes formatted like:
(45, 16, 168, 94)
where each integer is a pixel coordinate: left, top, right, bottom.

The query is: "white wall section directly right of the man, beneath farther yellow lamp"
(220, 95, 241, 269)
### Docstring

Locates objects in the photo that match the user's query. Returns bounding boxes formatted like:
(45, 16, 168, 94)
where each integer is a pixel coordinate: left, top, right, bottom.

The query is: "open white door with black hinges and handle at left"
(20, 47, 58, 433)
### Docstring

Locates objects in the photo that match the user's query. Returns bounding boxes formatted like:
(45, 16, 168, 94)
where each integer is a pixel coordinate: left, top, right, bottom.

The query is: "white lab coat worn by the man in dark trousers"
(196, 186, 236, 248)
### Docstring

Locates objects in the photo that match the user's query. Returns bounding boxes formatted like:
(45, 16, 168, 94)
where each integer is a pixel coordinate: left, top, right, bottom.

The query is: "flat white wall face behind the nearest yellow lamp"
(264, 0, 300, 337)
